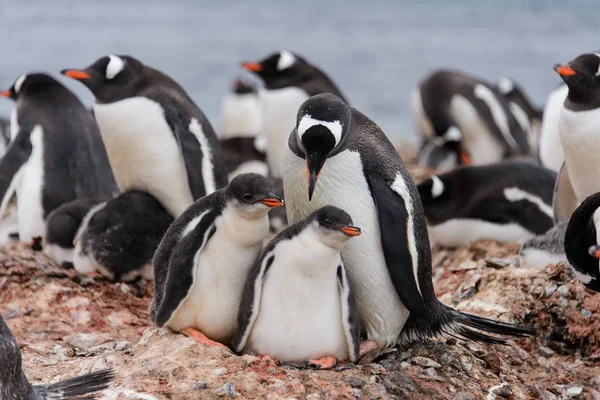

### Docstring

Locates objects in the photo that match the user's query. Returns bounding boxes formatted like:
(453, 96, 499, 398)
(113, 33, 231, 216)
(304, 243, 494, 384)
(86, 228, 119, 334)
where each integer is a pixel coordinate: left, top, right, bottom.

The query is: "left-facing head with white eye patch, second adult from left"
(61, 55, 145, 103)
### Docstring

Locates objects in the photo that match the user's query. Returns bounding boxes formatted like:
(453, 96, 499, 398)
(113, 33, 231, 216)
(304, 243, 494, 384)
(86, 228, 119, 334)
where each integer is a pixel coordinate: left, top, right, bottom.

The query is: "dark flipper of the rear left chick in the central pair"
(151, 210, 219, 326)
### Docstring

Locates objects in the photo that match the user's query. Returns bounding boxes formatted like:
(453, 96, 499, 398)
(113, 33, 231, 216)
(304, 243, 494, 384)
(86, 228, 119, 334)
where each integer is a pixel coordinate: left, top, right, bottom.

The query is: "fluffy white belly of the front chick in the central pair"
(244, 239, 349, 362)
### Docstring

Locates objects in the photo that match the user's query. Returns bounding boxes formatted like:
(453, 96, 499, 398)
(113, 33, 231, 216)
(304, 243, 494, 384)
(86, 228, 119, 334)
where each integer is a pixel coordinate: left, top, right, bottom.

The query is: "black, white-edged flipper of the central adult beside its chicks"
(368, 174, 431, 315)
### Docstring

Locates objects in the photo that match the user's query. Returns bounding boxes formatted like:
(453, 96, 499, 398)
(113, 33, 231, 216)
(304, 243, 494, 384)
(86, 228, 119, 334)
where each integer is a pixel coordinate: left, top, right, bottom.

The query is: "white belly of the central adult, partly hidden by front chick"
(284, 147, 409, 347)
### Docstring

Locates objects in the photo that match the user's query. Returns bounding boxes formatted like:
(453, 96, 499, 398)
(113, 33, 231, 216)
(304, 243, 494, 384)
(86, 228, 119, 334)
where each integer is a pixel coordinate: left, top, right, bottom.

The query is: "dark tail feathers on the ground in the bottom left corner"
(45, 369, 115, 399)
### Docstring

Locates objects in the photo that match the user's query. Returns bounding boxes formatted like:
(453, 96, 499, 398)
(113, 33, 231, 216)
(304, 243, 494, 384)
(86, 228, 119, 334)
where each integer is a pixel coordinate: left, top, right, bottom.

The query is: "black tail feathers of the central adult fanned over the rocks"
(398, 302, 535, 344)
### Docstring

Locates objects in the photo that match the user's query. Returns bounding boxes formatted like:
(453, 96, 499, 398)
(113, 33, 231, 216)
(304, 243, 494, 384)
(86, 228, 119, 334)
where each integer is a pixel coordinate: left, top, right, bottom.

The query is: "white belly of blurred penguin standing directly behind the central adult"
(259, 87, 309, 178)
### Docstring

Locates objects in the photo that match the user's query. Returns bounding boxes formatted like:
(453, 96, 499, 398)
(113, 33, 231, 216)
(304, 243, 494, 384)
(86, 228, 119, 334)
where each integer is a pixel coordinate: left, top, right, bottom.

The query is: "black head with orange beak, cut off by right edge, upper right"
(554, 53, 600, 104)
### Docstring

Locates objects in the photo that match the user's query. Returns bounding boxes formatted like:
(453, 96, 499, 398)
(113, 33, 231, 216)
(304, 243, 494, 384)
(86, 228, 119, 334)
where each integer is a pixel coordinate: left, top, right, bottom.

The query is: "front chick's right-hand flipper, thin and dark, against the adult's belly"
(337, 261, 360, 362)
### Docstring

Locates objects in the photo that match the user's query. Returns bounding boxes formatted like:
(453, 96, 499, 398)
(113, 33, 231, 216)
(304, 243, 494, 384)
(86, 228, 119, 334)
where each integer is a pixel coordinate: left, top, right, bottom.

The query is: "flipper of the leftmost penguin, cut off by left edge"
(0, 129, 33, 219)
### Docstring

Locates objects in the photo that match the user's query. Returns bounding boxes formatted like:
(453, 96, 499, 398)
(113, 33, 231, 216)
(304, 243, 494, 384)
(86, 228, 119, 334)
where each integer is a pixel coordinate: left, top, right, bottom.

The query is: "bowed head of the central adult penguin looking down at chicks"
(292, 93, 352, 200)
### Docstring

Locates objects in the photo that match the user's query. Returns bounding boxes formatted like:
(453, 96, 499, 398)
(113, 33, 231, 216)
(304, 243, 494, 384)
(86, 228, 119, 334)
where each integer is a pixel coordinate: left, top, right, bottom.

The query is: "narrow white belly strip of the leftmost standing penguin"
(14, 125, 46, 241)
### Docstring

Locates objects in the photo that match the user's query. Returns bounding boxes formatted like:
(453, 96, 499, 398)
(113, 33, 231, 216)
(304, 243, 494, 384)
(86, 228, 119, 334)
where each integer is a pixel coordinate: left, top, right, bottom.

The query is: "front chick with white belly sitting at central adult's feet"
(232, 206, 361, 368)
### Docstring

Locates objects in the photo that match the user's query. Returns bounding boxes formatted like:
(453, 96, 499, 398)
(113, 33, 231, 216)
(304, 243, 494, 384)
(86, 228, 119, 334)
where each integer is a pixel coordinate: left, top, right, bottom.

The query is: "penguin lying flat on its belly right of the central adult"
(418, 162, 556, 247)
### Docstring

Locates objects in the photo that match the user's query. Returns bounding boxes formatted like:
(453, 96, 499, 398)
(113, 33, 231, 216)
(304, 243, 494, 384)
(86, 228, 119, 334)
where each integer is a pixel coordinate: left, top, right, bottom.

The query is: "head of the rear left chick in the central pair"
(225, 174, 283, 218)
